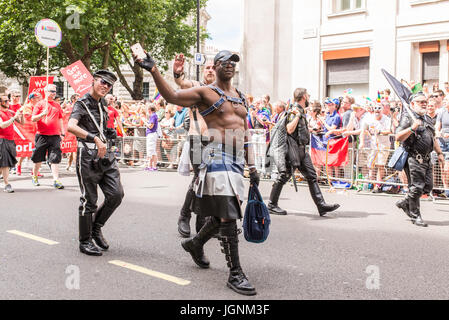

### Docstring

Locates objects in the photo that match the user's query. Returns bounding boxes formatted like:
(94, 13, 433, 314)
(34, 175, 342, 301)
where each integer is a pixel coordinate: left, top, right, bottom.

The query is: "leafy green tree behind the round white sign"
(0, 0, 207, 99)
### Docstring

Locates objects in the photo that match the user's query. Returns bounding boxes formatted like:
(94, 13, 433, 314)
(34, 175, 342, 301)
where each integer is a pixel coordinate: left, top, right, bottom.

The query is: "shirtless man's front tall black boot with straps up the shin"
(220, 220, 257, 296)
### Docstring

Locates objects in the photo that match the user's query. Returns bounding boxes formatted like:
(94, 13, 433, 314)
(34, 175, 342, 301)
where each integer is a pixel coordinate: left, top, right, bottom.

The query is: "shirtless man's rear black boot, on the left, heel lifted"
(181, 217, 220, 269)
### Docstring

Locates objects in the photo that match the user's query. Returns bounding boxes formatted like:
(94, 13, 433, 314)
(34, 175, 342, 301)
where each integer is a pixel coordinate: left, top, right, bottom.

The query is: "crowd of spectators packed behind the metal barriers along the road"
(2, 82, 449, 197)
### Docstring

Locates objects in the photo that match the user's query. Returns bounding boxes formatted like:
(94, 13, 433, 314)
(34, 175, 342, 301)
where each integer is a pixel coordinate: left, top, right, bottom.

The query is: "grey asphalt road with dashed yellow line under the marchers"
(0, 169, 449, 301)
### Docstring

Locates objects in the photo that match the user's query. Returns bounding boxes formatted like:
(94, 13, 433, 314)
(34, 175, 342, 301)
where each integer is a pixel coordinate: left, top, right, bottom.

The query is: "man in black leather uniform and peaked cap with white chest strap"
(68, 70, 124, 256)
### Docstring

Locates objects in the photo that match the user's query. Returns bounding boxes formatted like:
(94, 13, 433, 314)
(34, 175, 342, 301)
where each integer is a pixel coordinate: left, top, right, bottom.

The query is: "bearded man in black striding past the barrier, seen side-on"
(268, 88, 340, 216)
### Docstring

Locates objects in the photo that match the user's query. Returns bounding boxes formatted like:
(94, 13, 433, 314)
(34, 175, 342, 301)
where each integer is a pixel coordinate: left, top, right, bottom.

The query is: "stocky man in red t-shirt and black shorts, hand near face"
(31, 84, 65, 189)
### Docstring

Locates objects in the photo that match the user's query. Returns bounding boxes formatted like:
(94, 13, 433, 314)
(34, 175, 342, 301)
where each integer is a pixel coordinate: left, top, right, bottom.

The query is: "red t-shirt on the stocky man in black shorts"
(33, 100, 63, 136)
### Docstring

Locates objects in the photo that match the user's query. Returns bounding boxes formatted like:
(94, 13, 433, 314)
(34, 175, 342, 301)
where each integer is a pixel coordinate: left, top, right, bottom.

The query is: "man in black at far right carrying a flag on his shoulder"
(396, 92, 444, 227)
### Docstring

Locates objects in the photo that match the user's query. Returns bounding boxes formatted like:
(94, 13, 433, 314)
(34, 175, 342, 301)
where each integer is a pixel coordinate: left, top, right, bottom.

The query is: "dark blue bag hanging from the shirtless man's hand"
(243, 185, 271, 243)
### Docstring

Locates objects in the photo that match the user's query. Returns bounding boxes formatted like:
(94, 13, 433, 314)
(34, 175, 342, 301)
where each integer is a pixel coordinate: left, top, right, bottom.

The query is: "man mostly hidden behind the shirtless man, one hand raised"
(173, 54, 216, 238)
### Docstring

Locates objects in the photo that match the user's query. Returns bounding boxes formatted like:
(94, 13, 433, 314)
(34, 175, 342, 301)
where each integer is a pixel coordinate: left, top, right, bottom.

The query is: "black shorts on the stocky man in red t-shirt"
(31, 134, 62, 164)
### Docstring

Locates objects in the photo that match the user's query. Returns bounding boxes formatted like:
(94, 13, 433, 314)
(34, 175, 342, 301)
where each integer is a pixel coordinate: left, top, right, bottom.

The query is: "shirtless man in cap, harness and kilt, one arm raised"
(136, 50, 259, 295)
